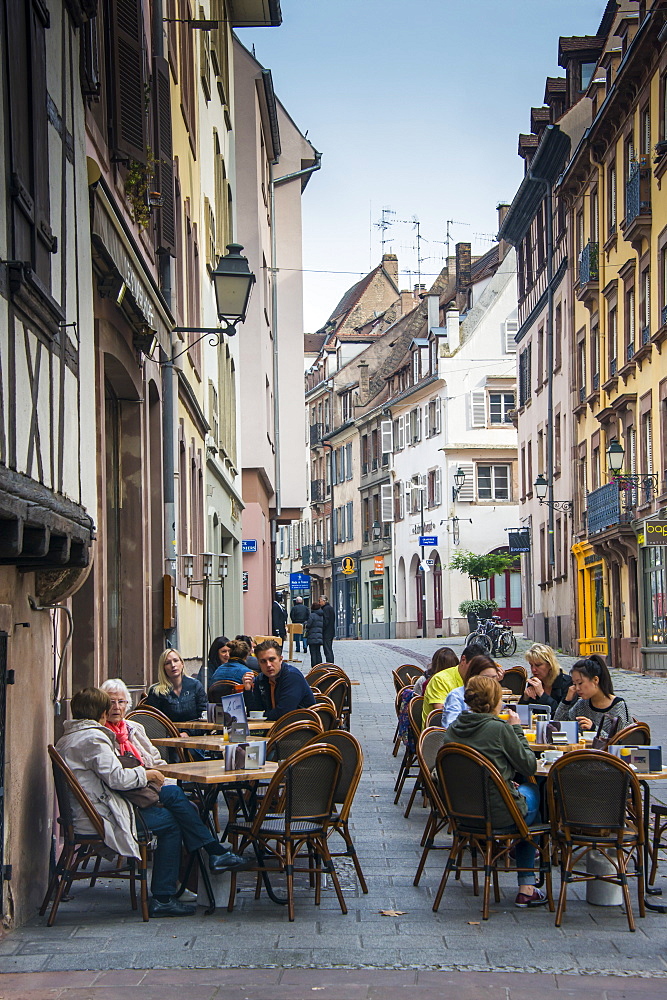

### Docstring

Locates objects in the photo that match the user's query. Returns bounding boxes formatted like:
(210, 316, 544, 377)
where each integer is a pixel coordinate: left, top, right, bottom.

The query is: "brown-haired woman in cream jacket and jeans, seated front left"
(56, 688, 244, 917)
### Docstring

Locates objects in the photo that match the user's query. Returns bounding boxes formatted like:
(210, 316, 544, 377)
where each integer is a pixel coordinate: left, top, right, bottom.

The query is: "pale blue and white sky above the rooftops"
(239, 0, 605, 332)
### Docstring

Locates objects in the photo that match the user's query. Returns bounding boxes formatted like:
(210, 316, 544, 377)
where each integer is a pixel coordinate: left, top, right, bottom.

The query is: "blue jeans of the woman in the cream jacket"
(139, 785, 215, 896)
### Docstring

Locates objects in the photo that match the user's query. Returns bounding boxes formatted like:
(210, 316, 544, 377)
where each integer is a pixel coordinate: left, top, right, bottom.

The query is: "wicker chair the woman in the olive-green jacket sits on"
(433, 743, 554, 920)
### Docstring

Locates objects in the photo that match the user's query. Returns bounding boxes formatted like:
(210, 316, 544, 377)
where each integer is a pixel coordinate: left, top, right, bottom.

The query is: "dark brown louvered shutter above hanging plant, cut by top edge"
(109, 0, 146, 164)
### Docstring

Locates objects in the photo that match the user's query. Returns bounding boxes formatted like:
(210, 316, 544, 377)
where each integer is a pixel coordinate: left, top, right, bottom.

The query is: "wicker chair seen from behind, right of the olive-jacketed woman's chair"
(547, 750, 645, 931)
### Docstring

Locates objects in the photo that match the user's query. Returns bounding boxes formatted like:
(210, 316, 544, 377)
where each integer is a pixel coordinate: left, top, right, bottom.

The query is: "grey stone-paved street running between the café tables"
(0, 639, 667, 988)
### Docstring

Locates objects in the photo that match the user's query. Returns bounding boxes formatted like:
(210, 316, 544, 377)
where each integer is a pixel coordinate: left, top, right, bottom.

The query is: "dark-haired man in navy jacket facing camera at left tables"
(243, 639, 315, 722)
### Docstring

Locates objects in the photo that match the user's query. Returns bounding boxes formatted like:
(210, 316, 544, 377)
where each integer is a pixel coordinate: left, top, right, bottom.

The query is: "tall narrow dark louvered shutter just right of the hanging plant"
(153, 53, 172, 258)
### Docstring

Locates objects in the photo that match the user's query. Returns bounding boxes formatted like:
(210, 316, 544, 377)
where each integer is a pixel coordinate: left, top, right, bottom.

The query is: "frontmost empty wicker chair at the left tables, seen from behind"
(227, 744, 347, 920)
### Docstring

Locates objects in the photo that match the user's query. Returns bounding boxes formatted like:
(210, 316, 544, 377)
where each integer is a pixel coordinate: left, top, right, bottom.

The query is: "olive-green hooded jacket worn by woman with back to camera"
(444, 712, 537, 826)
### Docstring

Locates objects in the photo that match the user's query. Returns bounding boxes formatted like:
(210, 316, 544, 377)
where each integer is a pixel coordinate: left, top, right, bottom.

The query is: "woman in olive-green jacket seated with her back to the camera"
(444, 677, 547, 907)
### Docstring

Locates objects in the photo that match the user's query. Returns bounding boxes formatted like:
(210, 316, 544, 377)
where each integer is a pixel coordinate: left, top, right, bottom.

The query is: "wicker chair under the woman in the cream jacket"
(39, 746, 148, 927)
